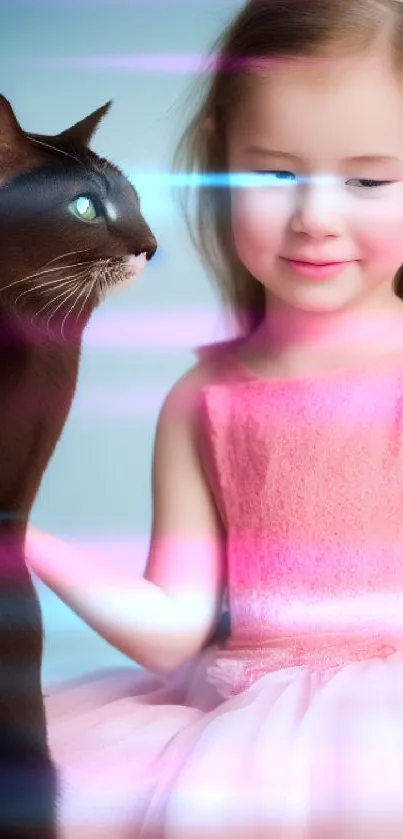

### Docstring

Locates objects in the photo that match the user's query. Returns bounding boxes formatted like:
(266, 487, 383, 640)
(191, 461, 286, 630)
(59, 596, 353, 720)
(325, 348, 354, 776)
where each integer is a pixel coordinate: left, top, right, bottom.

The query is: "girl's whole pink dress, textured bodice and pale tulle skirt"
(46, 344, 403, 839)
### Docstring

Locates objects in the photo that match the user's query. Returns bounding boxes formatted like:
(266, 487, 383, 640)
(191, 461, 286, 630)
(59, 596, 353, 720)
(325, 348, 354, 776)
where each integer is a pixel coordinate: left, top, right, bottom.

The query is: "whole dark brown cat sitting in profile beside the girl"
(0, 96, 156, 839)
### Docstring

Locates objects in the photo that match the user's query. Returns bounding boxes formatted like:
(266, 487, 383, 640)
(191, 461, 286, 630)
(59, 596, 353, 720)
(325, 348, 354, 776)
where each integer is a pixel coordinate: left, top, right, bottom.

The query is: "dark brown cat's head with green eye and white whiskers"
(0, 96, 157, 333)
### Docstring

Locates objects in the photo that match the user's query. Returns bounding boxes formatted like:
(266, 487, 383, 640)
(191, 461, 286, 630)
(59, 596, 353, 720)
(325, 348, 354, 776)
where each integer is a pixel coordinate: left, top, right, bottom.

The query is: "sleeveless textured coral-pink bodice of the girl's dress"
(202, 344, 403, 642)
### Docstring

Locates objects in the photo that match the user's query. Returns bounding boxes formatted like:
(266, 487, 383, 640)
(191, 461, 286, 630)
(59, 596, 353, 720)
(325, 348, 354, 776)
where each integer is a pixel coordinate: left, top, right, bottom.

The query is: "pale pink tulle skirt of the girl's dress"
(46, 636, 403, 839)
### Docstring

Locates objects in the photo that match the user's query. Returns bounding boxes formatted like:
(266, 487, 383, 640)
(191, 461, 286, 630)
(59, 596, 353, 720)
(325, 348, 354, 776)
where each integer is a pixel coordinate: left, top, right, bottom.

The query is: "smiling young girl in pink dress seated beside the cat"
(27, 0, 403, 839)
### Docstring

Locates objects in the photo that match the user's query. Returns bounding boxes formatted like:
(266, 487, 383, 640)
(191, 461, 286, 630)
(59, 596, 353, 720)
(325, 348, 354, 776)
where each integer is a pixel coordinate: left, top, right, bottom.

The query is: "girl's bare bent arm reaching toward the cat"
(26, 367, 224, 673)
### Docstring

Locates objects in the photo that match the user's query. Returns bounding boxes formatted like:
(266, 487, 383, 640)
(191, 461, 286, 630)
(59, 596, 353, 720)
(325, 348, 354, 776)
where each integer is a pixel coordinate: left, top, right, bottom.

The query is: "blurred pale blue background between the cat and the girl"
(0, 0, 242, 689)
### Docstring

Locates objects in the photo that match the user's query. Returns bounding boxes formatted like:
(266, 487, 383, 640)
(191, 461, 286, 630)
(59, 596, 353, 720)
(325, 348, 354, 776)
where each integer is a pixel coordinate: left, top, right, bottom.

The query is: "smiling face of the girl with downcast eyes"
(228, 53, 403, 312)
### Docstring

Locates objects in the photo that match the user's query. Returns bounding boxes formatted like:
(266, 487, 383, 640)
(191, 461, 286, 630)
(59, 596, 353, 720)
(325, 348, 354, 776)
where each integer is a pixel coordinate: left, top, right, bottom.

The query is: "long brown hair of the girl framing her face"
(173, 0, 403, 336)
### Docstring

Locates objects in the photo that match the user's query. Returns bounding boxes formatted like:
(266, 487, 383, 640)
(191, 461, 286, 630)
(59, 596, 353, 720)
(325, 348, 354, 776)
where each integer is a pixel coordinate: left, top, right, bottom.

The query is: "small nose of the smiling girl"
(291, 177, 345, 238)
